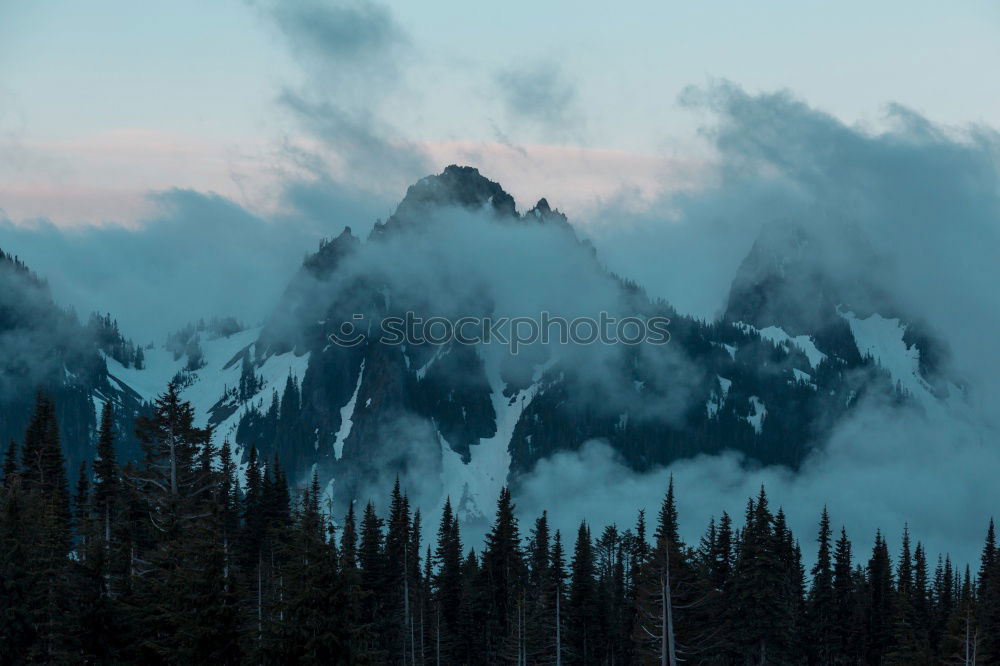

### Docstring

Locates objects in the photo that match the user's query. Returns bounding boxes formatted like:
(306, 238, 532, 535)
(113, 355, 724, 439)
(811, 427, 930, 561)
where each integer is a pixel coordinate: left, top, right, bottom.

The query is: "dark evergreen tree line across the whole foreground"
(0, 384, 1000, 666)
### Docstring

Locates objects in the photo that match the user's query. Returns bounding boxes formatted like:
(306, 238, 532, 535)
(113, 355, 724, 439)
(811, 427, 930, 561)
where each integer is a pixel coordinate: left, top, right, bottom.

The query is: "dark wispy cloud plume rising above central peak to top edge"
(258, 0, 430, 194)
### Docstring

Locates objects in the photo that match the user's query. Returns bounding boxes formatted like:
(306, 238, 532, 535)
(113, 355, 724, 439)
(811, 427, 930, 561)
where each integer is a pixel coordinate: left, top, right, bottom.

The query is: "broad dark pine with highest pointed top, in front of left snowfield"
(129, 383, 238, 663)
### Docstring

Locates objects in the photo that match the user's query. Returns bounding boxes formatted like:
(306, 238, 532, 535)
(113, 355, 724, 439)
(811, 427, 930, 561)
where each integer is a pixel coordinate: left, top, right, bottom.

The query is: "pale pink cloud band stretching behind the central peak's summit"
(0, 128, 705, 226)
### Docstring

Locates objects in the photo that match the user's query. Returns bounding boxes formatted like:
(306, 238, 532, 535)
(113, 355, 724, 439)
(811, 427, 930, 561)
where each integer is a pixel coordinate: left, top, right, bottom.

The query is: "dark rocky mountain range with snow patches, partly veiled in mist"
(0, 166, 963, 520)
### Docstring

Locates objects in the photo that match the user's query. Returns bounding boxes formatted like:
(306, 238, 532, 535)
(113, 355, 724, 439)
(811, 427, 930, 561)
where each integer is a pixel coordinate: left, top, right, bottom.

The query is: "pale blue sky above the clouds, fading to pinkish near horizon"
(0, 0, 1000, 221)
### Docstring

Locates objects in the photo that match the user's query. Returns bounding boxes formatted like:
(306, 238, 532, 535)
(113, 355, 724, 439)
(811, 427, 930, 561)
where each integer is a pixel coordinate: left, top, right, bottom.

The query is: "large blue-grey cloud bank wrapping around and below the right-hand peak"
(521, 83, 1000, 562)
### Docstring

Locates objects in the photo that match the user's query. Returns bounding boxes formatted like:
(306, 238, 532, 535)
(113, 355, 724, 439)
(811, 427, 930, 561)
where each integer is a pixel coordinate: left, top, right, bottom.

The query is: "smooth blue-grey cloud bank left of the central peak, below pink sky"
(0, 190, 379, 343)
